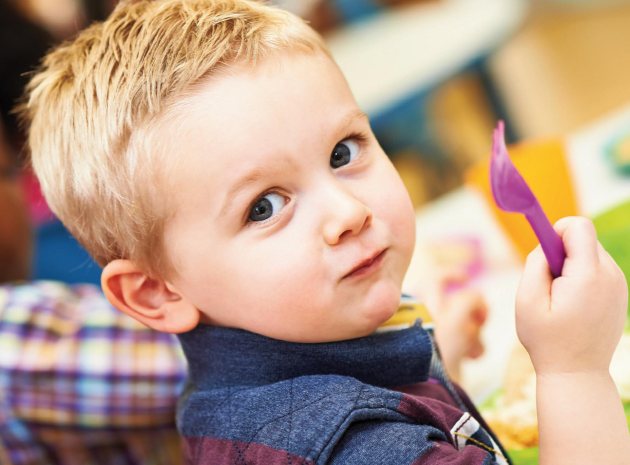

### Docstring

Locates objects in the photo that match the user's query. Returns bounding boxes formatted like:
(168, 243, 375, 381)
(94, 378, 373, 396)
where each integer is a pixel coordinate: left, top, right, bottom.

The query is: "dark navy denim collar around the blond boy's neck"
(179, 322, 433, 389)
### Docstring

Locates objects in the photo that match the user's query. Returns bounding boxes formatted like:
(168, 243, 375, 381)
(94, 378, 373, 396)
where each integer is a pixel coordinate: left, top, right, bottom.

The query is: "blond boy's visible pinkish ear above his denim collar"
(101, 260, 201, 333)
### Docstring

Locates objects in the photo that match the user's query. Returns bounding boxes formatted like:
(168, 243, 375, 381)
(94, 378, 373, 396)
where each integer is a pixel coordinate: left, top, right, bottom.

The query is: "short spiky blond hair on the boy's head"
(20, 0, 326, 276)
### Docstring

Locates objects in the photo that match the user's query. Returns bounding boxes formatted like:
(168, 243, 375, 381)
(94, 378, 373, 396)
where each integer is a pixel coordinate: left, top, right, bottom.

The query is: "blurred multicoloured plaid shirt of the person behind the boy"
(0, 281, 186, 465)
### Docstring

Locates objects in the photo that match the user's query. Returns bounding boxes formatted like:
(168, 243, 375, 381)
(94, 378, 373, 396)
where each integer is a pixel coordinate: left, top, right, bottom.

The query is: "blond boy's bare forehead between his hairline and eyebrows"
(158, 49, 368, 191)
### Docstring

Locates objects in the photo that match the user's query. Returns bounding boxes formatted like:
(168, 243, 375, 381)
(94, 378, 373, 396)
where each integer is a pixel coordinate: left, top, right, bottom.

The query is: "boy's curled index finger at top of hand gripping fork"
(554, 217, 599, 266)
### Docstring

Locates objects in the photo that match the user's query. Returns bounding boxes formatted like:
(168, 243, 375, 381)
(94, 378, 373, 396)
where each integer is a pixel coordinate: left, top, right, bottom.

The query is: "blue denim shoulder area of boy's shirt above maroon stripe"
(178, 374, 402, 440)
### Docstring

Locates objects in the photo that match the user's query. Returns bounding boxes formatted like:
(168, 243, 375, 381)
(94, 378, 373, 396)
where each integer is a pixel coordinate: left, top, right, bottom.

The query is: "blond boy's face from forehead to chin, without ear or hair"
(161, 53, 415, 342)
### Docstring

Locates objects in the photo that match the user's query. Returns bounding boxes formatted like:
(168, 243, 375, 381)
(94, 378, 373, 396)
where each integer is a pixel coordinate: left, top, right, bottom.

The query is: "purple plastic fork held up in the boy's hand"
(490, 121, 566, 278)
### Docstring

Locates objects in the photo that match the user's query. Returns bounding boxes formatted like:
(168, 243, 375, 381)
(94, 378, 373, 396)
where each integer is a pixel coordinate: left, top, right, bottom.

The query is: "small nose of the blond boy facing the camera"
(323, 185, 372, 245)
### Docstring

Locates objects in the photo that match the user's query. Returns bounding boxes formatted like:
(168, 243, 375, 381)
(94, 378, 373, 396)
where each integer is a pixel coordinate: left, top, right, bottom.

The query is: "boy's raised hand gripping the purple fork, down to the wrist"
(516, 217, 628, 375)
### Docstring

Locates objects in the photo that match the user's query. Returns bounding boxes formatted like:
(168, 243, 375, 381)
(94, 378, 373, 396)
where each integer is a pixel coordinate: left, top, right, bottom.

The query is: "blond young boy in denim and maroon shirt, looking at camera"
(19, 0, 630, 465)
